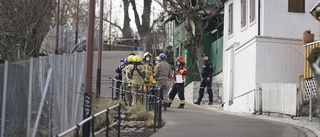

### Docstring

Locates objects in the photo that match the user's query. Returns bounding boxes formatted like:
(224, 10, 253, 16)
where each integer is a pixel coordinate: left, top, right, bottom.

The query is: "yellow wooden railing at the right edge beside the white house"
(303, 41, 320, 80)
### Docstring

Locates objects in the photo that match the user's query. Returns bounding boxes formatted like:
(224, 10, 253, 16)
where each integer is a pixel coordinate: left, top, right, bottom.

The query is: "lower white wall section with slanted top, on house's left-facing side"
(230, 39, 256, 113)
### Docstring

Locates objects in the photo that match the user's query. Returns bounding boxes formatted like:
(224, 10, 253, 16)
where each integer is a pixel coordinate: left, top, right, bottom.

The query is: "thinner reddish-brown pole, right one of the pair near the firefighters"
(96, 0, 104, 98)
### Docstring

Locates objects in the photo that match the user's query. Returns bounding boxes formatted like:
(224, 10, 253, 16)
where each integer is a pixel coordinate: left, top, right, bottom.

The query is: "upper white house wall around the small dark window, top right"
(262, 0, 319, 40)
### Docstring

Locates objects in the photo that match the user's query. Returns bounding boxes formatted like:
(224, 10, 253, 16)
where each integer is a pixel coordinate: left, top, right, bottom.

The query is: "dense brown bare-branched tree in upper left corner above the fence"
(0, 0, 55, 61)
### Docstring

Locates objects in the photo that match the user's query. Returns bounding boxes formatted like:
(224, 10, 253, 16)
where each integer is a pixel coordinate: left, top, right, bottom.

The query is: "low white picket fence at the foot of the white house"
(261, 83, 297, 116)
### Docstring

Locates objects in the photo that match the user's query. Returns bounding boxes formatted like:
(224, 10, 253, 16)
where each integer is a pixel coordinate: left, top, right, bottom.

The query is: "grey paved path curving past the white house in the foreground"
(151, 98, 320, 137)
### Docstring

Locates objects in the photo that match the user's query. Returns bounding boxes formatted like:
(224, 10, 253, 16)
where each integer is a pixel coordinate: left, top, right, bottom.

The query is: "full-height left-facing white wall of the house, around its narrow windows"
(223, 0, 258, 112)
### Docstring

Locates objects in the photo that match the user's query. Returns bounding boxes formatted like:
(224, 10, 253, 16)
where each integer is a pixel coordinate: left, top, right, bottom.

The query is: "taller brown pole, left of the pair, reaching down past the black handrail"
(82, 0, 96, 137)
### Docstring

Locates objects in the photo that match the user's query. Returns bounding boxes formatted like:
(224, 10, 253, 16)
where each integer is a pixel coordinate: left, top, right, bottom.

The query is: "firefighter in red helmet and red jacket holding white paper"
(168, 56, 188, 108)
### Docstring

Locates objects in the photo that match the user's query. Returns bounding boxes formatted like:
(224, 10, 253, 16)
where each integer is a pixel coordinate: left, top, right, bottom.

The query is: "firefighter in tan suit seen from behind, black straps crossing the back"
(127, 55, 146, 104)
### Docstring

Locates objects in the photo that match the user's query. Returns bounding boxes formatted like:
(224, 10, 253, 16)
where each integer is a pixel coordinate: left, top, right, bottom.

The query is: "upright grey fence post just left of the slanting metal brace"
(27, 58, 33, 137)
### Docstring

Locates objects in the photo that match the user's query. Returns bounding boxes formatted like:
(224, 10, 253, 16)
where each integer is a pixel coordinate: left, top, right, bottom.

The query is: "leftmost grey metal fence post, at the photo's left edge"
(1, 61, 9, 137)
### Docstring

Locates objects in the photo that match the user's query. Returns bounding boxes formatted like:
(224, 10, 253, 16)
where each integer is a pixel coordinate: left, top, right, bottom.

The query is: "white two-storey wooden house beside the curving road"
(223, 0, 319, 113)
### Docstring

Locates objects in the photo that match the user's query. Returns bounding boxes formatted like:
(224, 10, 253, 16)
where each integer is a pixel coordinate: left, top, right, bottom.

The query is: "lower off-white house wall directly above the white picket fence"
(256, 37, 304, 83)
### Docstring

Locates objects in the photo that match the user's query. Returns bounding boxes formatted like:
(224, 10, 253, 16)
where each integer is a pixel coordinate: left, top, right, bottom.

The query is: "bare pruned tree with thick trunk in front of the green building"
(157, 0, 224, 75)
